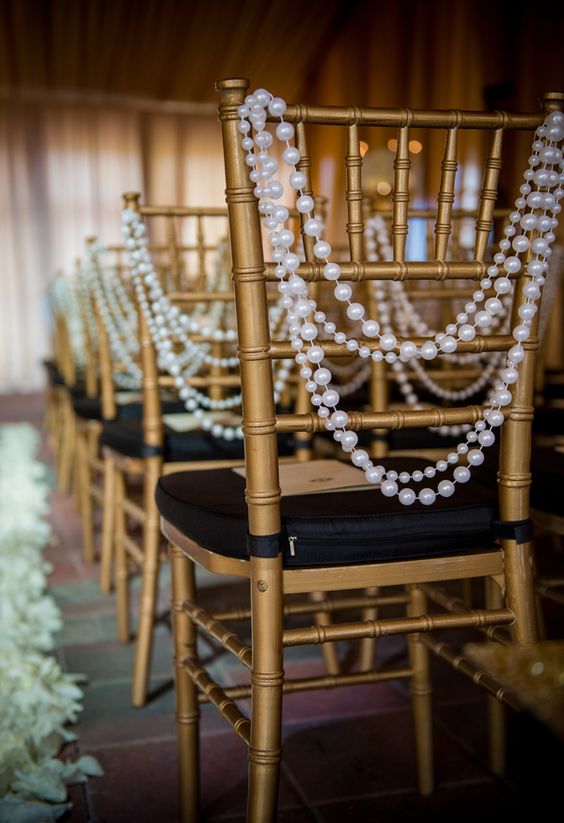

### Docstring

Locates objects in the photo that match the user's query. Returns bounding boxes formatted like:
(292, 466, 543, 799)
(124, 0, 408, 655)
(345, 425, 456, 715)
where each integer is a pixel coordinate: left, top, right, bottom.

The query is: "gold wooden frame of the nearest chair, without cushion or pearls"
(162, 79, 564, 823)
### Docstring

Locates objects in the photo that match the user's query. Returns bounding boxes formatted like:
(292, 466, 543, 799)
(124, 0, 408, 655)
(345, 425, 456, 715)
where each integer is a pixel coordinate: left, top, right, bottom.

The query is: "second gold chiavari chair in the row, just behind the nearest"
(100, 194, 251, 706)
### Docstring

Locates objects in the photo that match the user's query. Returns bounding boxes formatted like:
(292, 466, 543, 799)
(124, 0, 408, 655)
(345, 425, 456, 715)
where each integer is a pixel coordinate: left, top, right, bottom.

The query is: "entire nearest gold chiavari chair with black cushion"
(157, 79, 564, 823)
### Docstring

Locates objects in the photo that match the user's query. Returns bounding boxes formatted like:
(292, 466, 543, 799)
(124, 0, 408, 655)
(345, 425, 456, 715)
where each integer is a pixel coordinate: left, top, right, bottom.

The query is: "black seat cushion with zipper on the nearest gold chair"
(156, 458, 497, 567)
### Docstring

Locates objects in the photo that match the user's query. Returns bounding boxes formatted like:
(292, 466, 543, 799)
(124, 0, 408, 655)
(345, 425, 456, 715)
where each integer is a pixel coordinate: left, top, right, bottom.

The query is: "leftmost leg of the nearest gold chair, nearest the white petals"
(170, 545, 200, 823)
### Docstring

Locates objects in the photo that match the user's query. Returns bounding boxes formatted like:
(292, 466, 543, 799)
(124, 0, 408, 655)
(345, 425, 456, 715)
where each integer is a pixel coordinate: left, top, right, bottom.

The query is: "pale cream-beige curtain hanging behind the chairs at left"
(0, 103, 225, 393)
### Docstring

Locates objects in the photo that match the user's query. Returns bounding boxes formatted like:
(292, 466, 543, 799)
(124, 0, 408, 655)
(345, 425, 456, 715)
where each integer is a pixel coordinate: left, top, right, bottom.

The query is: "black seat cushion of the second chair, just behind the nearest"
(100, 419, 243, 462)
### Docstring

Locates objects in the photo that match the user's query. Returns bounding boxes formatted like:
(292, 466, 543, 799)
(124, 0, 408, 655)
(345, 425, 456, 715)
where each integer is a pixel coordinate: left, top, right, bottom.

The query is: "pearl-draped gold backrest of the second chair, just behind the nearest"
(119, 193, 240, 447)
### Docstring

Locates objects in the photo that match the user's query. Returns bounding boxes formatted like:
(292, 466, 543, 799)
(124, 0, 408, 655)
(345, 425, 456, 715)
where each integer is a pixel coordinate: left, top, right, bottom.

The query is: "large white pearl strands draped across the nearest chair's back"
(238, 89, 564, 506)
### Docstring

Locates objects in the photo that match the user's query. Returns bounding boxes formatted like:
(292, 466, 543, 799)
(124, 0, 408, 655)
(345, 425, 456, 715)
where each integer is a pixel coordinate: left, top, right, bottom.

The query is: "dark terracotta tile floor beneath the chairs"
(0, 396, 564, 823)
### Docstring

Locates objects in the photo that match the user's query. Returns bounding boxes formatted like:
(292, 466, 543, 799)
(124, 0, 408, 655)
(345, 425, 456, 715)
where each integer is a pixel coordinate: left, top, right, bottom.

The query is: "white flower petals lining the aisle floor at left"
(0, 424, 102, 823)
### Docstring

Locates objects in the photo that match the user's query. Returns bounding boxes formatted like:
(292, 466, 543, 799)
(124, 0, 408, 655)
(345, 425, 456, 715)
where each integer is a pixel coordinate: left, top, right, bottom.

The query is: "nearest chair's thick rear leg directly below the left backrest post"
(247, 555, 284, 823)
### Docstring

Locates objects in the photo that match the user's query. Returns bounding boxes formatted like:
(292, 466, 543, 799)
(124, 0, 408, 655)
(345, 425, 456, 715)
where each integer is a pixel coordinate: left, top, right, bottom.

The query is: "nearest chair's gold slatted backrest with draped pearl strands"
(218, 79, 564, 536)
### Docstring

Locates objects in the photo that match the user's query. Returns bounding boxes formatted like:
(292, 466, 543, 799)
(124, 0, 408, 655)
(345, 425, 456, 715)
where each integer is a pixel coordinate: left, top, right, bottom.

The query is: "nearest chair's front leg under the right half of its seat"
(408, 586, 435, 794)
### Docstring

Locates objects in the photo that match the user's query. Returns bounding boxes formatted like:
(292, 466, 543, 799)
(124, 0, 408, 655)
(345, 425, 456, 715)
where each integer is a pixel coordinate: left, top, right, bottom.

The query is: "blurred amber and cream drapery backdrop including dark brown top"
(0, 0, 564, 392)
